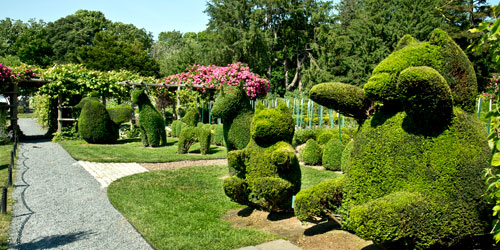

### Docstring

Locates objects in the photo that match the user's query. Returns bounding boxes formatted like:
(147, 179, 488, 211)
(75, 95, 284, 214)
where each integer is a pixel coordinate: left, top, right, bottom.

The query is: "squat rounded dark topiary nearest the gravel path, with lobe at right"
(76, 97, 132, 144)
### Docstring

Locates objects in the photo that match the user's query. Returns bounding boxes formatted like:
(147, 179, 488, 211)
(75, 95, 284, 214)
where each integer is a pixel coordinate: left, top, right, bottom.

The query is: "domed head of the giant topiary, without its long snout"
(363, 29, 477, 112)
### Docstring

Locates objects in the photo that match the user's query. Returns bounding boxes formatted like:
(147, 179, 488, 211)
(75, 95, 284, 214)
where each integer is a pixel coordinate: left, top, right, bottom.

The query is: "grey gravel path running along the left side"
(9, 119, 152, 249)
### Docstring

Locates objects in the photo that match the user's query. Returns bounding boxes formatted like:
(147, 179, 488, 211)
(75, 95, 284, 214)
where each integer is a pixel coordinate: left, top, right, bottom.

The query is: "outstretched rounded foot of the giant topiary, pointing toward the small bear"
(295, 176, 344, 221)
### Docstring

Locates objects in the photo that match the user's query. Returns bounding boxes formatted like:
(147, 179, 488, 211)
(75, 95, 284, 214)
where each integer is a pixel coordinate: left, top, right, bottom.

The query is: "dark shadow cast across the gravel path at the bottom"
(14, 232, 94, 249)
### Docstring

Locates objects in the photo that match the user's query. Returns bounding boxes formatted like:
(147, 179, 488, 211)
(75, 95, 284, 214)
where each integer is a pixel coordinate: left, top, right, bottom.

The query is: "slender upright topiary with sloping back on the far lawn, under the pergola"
(132, 88, 167, 147)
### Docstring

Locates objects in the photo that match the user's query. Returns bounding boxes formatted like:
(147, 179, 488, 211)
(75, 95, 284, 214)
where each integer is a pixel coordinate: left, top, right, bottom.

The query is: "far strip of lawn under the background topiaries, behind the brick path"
(59, 137, 226, 162)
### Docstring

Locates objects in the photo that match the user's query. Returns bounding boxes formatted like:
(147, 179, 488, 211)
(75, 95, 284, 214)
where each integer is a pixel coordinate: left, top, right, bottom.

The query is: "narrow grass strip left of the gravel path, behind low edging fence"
(0, 144, 14, 249)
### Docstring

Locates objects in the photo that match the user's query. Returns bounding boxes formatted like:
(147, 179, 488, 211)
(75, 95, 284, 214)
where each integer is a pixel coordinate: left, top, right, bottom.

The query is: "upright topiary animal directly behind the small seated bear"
(212, 85, 254, 152)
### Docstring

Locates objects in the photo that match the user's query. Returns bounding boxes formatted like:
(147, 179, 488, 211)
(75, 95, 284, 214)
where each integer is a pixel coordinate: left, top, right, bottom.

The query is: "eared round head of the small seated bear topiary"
(250, 103, 295, 145)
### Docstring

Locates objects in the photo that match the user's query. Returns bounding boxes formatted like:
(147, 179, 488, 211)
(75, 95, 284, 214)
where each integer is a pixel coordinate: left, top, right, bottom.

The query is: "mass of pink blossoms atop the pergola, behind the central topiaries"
(165, 62, 269, 100)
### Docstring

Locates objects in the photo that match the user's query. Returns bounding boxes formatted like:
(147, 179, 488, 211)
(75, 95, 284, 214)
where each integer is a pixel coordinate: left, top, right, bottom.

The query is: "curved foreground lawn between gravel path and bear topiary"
(108, 166, 339, 250)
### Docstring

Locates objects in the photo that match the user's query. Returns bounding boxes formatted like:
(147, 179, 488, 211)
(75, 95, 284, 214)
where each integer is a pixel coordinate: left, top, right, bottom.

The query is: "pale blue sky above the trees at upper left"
(0, 0, 208, 39)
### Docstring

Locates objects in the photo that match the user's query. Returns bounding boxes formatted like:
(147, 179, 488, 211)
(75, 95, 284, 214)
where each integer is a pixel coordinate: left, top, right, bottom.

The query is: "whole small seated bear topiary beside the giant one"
(224, 103, 301, 212)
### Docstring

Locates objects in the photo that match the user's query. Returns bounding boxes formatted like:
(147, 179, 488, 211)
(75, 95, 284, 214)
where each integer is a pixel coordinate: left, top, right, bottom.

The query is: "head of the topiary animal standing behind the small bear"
(212, 85, 251, 119)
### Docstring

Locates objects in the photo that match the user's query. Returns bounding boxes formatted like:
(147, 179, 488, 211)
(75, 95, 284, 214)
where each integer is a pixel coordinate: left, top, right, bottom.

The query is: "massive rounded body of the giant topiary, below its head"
(344, 109, 490, 248)
